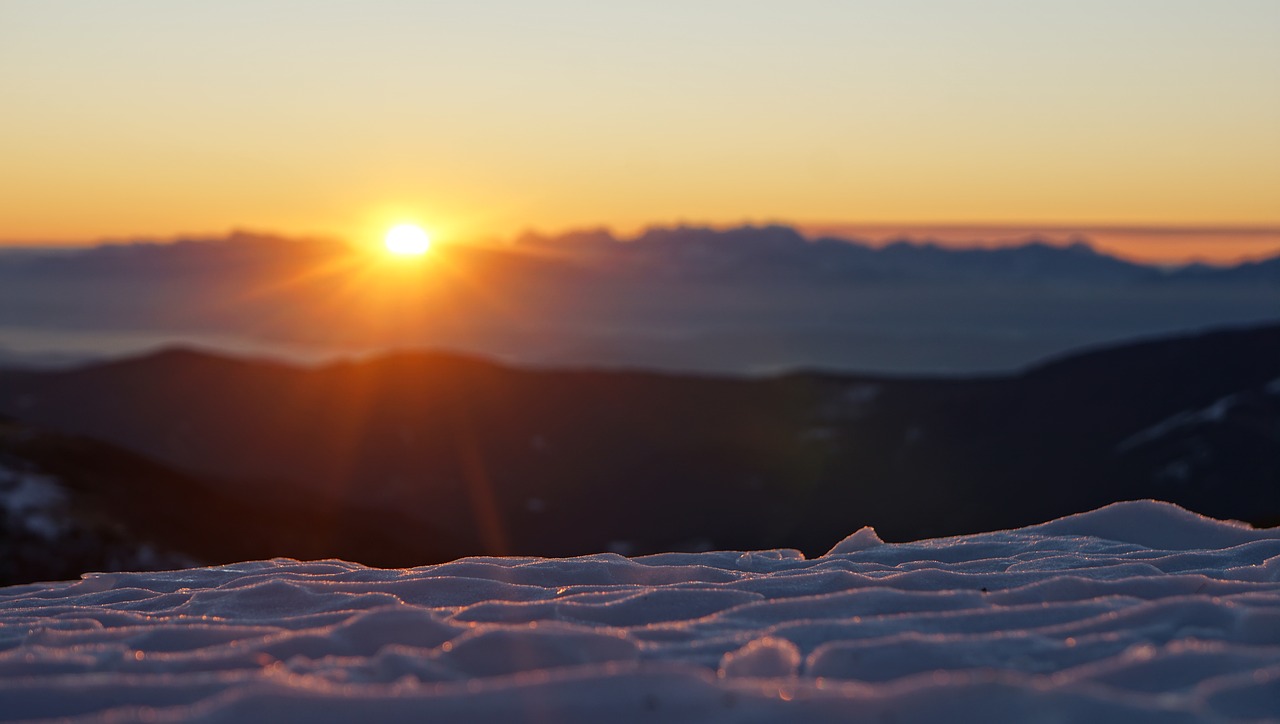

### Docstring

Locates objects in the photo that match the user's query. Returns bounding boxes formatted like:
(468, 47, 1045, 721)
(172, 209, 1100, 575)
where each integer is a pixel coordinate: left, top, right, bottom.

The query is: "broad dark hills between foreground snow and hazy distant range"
(0, 326, 1280, 570)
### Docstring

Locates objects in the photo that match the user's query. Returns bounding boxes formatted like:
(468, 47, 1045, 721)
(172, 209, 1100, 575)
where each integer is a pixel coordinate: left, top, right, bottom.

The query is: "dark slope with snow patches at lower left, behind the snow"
(0, 418, 467, 586)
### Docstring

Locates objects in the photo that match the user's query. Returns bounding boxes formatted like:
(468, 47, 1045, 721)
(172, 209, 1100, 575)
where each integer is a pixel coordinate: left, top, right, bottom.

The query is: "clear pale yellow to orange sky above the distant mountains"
(0, 0, 1280, 255)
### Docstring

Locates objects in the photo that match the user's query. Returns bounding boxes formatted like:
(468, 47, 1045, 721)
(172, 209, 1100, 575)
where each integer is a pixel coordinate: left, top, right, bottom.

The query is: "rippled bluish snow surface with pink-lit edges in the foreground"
(0, 501, 1280, 724)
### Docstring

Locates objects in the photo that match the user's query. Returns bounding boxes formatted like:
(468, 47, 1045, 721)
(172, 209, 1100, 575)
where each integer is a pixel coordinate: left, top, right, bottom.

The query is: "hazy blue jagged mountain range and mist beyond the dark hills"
(0, 226, 1280, 374)
